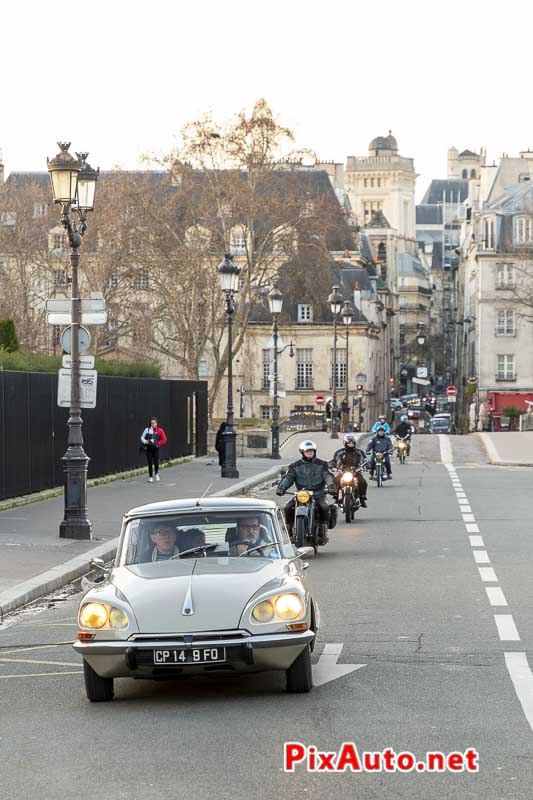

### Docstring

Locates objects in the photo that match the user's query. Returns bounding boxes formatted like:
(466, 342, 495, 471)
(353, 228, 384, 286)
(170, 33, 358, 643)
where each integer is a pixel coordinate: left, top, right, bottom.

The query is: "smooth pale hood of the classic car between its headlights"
(112, 557, 287, 633)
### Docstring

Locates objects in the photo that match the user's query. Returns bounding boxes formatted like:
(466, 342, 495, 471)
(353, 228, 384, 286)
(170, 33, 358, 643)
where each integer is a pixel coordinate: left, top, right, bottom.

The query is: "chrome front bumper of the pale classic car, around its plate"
(73, 631, 315, 679)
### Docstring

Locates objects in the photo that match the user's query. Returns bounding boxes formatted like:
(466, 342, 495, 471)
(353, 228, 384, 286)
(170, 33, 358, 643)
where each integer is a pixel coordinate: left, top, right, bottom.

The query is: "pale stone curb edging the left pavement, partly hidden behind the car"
(0, 464, 285, 623)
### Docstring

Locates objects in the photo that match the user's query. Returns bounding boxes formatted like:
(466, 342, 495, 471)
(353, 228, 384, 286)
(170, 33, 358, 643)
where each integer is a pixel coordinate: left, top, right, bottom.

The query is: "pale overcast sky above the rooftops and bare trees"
(0, 0, 533, 198)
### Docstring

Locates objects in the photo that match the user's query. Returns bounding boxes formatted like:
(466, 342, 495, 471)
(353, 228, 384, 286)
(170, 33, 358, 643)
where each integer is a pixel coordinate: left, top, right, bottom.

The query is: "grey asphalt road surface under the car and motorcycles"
(0, 436, 533, 800)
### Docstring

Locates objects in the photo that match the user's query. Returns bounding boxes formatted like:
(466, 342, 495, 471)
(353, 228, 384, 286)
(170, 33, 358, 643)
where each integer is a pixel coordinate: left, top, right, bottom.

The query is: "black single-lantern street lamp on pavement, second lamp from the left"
(218, 254, 241, 478)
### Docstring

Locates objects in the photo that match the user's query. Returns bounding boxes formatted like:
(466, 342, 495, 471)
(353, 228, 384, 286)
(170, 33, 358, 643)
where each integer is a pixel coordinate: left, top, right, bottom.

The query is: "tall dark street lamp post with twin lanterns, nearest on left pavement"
(47, 142, 98, 539)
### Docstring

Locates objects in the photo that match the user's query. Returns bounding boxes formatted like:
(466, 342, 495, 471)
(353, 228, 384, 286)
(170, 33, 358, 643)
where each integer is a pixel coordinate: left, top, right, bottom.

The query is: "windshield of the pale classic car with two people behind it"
(117, 511, 289, 566)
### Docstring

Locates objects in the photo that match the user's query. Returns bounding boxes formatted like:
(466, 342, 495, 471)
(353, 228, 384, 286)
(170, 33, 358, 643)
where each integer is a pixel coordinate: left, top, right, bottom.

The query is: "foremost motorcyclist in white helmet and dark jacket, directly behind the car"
(276, 439, 337, 544)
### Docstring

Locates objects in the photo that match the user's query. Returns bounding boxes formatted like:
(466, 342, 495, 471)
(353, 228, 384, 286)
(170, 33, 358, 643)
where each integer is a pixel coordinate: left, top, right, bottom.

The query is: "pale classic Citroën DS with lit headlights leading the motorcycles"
(73, 497, 319, 702)
